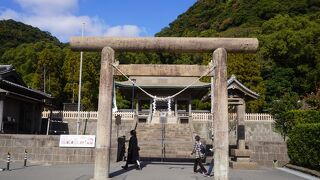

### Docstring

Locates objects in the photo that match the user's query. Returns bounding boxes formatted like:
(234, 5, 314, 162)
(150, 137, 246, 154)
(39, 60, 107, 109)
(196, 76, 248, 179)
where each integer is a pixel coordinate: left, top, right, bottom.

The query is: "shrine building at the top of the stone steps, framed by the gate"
(115, 75, 212, 124)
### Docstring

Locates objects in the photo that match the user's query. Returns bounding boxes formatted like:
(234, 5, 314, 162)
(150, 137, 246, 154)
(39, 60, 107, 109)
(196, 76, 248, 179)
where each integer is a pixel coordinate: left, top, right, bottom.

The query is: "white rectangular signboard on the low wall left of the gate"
(59, 135, 96, 148)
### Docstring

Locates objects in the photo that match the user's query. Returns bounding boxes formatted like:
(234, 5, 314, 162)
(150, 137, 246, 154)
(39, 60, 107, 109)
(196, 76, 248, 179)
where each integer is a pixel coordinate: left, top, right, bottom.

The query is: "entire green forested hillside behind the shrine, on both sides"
(0, 0, 320, 112)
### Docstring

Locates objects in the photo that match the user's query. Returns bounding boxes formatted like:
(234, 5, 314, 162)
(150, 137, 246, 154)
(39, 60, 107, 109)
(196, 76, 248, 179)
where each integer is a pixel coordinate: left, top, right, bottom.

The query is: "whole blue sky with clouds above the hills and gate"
(0, 0, 196, 42)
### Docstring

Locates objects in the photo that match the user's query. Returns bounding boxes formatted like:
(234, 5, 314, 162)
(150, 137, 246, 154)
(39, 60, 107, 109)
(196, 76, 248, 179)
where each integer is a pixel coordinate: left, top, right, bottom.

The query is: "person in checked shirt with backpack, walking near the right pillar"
(191, 135, 207, 174)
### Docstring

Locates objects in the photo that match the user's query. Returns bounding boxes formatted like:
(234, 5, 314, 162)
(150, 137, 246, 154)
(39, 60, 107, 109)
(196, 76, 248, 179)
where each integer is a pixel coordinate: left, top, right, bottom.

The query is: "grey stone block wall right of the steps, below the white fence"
(193, 121, 289, 167)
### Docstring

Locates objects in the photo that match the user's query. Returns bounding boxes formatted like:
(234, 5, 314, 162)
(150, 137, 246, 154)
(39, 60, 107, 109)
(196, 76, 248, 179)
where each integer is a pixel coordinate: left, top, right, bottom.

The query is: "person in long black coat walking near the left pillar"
(121, 130, 141, 170)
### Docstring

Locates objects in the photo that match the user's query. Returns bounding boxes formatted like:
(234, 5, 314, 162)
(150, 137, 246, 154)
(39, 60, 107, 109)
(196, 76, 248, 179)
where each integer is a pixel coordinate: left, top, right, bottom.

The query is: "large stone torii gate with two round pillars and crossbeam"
(70, 37, 259, 180)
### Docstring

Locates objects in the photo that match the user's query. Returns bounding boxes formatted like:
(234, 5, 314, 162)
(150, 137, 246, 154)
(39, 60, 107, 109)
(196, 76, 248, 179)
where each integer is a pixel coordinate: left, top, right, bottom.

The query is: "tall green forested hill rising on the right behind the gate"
(156, 0, 320, 111)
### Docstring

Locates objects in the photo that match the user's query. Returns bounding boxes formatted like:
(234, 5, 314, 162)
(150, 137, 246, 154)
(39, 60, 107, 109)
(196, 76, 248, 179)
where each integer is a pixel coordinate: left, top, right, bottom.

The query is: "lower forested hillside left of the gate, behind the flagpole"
(0, 20, 100, 110)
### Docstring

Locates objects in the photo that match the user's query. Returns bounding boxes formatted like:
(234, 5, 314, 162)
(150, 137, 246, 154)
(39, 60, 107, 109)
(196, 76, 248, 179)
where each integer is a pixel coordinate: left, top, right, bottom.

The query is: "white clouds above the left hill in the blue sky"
(0, 0, 144, 42)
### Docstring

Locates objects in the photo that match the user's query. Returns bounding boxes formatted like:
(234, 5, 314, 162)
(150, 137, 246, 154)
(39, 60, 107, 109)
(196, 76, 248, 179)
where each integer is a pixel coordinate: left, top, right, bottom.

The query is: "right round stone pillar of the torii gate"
(211, 48, 229, 180)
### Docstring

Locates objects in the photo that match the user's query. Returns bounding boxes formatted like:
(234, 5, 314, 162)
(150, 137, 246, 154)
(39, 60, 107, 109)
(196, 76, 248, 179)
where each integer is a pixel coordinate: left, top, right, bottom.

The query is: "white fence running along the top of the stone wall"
(42, 111, 273, 121)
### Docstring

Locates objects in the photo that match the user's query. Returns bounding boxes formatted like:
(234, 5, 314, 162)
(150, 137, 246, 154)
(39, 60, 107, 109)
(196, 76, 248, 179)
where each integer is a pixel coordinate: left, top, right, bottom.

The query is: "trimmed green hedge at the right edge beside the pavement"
(287, 123, 320, 170)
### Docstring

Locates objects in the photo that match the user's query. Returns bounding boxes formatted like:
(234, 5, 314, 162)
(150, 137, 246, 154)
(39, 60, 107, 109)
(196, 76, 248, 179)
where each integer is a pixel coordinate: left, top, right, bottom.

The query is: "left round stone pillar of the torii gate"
(93, 47, 114, 180)
